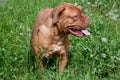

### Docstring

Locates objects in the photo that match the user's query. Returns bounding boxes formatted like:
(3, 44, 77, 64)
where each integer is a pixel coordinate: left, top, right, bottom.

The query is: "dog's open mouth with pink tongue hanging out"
(68, 28, 90, 37)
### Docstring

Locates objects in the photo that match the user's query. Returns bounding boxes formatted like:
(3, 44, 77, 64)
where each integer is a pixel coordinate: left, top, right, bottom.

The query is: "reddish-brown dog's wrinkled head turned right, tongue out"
(52, 3, 90, 37)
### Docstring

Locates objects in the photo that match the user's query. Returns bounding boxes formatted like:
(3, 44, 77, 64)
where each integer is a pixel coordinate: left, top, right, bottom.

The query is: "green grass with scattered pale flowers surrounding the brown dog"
(0, 0, 120, 80)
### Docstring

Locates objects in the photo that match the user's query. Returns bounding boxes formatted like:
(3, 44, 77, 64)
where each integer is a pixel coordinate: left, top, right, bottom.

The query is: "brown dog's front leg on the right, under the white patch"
(59, 53, 68, 72)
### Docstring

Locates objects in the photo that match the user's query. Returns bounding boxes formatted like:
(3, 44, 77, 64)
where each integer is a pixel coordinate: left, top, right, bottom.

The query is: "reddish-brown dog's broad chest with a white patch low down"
(38, 25, 66, 57)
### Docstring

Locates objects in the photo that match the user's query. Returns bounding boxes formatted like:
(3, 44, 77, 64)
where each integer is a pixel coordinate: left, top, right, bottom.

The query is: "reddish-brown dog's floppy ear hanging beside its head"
(51, 6, 65, 24)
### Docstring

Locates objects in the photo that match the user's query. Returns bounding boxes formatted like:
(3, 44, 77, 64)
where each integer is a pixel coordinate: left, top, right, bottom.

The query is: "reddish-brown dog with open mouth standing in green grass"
(32, 3, 90, 72)
